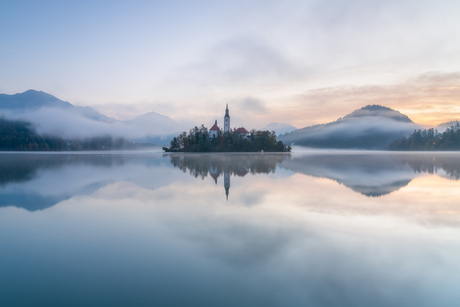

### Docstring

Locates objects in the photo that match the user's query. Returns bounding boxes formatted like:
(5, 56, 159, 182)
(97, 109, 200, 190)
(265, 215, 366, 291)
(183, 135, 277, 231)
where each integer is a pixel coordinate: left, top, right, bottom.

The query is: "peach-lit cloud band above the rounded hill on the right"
(279, 72, 460, 127)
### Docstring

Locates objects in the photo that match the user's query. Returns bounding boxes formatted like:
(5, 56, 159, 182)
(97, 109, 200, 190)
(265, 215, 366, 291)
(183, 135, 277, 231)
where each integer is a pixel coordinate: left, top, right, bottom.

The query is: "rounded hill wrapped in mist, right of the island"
(279, 105, 419, 149)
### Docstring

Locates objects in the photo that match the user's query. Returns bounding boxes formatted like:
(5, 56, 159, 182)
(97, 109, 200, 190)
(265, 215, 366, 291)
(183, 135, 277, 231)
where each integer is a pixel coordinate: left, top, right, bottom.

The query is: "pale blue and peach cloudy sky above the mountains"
(0, 0, 460, 129)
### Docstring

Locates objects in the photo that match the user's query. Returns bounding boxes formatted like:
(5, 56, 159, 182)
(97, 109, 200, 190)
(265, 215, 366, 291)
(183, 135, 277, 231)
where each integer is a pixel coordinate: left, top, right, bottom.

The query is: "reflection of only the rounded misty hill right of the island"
(282, 154, 417, 197)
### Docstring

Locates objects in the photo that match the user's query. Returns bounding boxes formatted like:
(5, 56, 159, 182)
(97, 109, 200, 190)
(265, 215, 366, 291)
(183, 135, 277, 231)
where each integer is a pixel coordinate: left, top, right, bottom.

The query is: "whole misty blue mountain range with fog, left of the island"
(0, 90, 181, 144)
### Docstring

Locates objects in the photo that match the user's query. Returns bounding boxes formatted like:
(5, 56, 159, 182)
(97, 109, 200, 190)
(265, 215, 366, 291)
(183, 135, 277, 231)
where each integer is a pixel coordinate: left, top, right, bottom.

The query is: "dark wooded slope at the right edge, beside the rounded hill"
(388, 122, 460, 150)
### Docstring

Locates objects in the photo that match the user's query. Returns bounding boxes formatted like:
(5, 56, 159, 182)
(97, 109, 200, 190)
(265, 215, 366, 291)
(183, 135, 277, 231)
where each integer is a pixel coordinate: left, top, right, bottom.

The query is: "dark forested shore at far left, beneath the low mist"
(0, 117, 133, 151)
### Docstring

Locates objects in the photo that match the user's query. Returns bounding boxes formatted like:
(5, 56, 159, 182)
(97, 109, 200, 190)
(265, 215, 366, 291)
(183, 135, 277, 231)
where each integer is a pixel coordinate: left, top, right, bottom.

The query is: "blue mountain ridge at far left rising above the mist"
(0, 90, 116, 122)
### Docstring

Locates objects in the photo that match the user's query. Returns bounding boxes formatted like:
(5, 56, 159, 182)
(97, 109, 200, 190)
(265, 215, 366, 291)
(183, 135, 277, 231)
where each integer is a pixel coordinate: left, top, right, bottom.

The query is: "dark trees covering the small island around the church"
(163, 125, 291, 152)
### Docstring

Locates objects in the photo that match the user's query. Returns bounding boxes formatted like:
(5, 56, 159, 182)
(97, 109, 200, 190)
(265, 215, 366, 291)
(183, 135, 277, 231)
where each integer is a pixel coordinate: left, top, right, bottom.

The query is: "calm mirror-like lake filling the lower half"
(0, 148, 460, 307)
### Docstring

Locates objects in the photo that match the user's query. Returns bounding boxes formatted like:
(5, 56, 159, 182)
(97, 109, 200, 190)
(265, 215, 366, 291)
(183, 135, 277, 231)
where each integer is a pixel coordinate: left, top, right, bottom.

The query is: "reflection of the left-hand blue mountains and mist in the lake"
(0, 154, 170, 211)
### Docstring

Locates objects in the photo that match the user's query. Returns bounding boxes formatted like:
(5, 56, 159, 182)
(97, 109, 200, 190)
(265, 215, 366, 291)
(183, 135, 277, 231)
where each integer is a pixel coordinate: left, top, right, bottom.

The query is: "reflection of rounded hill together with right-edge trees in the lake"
(282, 152, 460, 197)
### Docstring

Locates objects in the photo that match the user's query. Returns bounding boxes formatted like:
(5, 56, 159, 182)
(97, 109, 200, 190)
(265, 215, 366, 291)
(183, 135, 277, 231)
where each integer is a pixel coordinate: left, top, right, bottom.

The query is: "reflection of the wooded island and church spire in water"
(165, 153, 290, 200)
